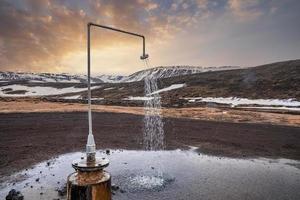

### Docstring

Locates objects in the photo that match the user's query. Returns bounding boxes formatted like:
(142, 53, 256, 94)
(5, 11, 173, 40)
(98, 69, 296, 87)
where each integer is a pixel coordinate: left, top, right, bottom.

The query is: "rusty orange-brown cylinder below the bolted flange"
(67, 170, 111, 200)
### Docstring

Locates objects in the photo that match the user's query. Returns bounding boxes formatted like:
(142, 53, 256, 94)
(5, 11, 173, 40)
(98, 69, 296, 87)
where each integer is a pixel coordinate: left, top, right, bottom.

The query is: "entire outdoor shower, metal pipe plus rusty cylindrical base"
(67, 23, 148, 200)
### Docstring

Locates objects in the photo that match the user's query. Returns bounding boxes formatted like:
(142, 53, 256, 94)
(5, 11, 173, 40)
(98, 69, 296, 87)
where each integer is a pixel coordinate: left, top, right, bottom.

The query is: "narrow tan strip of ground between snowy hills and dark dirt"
(0, 100, 300, 127)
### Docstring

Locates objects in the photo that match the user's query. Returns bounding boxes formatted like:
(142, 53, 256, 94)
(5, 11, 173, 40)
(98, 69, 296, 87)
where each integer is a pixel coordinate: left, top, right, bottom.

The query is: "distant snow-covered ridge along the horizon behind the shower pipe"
(0, 66, 239, 83)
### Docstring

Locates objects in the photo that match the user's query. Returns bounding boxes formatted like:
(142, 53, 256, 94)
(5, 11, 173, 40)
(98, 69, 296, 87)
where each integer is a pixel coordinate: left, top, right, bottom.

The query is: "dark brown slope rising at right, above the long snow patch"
(160, 60, 300, 100)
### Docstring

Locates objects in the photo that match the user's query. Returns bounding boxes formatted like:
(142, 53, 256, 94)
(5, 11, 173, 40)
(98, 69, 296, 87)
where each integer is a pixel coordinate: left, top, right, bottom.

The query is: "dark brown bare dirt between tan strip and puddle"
(0, 112, 300, 177)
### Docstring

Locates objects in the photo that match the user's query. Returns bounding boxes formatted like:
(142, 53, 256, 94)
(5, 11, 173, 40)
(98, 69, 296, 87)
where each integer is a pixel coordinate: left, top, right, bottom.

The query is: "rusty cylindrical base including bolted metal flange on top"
(67, 156, 111, 200)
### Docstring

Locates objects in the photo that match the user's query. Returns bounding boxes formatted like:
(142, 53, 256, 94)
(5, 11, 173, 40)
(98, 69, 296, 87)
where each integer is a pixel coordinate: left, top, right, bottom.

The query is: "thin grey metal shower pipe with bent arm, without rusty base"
(86, 22, 148, 161)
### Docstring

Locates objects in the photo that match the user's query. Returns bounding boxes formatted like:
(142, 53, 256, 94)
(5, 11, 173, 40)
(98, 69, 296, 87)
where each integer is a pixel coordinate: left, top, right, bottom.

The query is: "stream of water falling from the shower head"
(144, 59, 164, 151)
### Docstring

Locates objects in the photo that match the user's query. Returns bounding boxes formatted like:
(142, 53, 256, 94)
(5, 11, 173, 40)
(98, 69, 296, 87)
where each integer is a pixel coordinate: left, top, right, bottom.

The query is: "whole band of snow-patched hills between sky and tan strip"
(0, 60, 300, 110)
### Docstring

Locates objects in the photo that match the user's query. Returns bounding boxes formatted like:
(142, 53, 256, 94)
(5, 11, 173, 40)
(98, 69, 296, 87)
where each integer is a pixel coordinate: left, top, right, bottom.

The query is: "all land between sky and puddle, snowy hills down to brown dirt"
(0, 60, 300, 176)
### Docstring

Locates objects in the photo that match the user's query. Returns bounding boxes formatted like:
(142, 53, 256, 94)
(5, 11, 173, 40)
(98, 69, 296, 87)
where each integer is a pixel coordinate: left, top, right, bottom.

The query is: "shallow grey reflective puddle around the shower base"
(0, 149, 300, 200)
